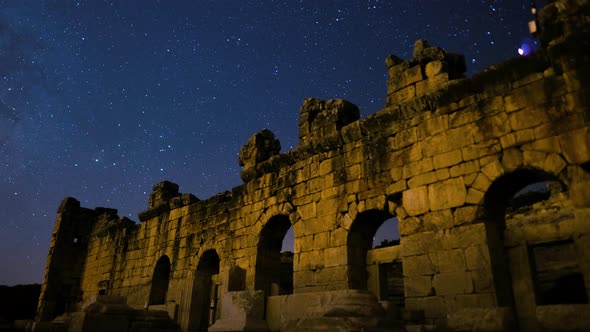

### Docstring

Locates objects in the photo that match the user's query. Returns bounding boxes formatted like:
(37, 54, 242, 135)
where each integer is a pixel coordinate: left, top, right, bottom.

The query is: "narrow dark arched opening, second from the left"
(188, 249, 219, 331)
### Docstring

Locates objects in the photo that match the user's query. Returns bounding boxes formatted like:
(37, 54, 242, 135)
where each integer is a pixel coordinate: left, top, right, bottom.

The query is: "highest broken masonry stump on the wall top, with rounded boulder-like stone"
(385, 39, 466, 107)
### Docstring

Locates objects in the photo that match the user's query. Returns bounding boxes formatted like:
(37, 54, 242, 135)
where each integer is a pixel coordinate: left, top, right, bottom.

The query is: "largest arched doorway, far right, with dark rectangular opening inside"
(484, 168, 587, 331)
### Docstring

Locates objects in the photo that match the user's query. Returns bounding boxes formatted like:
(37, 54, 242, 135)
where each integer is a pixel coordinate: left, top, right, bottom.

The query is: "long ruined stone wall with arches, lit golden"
(38, 0, 590, 331)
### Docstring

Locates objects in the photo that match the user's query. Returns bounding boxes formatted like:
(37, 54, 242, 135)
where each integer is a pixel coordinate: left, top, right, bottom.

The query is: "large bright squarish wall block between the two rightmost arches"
(428, 178, 467, 211)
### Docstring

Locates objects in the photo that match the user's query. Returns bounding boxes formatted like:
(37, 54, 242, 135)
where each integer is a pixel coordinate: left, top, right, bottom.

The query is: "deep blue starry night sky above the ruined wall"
(0, 0, 544, 285)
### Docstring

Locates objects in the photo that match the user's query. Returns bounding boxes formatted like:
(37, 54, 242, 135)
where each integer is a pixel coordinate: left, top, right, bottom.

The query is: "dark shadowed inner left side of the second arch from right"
(346, 209, 393, 290)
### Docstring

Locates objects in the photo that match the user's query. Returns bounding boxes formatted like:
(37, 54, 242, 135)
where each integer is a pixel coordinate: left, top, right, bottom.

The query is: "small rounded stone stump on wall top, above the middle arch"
(240, 129, 281, 182)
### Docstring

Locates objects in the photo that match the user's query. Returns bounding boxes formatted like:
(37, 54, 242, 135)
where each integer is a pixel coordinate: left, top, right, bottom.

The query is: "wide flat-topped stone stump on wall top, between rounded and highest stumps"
(299, 98, 360, 146)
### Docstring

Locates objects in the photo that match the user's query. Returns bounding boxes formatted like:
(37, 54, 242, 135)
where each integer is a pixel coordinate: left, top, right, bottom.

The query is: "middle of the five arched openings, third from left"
(254, 215, 293, 296)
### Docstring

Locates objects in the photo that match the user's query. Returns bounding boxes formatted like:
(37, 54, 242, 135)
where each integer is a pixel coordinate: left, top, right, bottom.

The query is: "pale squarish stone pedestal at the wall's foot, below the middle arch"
(209, 290, 268, 332)
